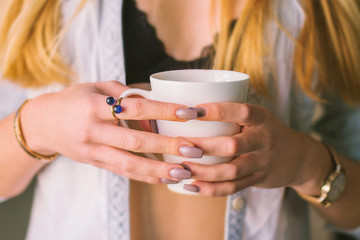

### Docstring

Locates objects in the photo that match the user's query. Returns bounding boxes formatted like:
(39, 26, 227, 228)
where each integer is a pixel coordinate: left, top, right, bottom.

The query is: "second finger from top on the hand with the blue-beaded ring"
(90, 123, 198, 157)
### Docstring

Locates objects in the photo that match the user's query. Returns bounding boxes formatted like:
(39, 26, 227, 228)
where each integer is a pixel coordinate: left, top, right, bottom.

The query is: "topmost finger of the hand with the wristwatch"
(197, 102, 266, 126)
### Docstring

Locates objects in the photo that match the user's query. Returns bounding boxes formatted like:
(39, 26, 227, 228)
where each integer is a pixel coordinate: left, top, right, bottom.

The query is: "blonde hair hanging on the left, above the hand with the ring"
(0, 0, 86, 87)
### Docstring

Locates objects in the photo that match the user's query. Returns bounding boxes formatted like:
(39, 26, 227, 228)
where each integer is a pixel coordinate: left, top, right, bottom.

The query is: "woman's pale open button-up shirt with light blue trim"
(0, 0, 360, 240)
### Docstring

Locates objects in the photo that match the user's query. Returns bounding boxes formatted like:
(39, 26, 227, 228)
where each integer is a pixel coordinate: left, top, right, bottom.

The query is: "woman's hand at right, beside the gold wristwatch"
(184, 103, 331, 196)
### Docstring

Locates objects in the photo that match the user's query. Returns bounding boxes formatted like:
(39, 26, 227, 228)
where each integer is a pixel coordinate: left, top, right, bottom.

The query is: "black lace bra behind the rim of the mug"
(122, 0, 212, 84)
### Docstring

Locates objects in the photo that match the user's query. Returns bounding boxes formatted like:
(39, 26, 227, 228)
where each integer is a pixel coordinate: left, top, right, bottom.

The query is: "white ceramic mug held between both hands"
(120, 69, 249, 194)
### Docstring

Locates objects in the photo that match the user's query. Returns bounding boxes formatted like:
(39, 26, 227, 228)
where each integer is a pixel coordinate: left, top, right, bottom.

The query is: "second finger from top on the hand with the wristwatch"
(186, 129, 263, 157)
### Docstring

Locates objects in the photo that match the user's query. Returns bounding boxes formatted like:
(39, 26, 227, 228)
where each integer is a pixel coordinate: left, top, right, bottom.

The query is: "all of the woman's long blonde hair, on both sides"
(0, 0, 360, 104)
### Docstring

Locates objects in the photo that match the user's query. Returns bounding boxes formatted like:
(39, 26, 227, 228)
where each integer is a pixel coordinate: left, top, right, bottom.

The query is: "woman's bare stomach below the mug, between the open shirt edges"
(130, 181, 226, 240)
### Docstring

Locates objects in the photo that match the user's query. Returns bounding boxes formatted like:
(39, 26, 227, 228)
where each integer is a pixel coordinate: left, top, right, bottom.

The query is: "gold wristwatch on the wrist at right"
(298, 144, 346, 207)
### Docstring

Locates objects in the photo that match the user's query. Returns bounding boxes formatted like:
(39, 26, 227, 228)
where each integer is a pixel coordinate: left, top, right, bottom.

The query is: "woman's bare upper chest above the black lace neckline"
(135, 0, 244, 61)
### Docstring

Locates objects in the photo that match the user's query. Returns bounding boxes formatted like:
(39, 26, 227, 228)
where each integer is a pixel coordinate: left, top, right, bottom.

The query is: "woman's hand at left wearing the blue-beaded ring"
(22, 81, 198, 183)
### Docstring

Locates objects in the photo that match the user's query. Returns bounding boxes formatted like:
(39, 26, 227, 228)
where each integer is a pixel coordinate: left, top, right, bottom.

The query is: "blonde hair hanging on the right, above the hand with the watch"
(214, 0, 360, 104)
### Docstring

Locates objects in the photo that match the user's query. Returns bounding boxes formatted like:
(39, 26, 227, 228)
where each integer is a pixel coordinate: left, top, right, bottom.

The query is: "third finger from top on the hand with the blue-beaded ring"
(91, 145, 191, 183)
